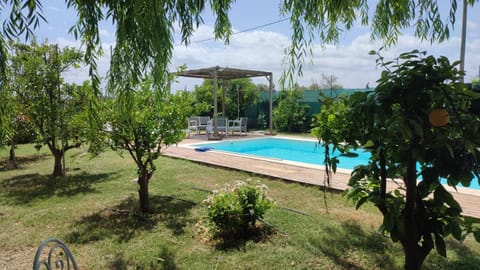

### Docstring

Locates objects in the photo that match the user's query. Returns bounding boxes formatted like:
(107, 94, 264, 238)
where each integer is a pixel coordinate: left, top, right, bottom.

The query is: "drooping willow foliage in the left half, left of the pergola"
(0, 0, 233, 147)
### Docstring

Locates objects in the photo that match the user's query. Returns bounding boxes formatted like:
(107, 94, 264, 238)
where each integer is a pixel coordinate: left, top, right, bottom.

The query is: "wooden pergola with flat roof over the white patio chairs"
(176, 66, 273, 137)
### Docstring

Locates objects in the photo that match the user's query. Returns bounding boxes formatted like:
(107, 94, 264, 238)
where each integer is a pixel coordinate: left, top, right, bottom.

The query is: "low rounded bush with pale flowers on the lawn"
(204, 180, 275, 237)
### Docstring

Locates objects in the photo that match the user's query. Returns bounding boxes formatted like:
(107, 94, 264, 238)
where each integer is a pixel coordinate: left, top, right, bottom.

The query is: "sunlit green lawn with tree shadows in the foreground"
(0, 145, 480, 270)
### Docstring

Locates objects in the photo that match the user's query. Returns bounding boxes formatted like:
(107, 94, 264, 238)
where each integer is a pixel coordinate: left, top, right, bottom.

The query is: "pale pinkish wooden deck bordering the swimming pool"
(163, 134, 480, 218)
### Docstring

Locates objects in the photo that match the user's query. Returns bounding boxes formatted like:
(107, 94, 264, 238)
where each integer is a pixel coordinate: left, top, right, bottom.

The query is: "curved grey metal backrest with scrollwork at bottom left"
(33, 238, 78, 270)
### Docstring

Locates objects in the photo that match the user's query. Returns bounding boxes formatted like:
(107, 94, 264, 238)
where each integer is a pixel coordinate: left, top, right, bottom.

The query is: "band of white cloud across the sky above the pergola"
(172, 28, 480, 89)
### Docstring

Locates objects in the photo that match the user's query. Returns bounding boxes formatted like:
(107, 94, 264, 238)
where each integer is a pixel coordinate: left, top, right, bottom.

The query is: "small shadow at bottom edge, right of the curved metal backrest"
(108, 247, 178, 270)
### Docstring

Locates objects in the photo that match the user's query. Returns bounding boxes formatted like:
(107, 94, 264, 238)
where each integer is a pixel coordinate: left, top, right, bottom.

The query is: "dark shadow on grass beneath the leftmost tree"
(0, 172, 114, 204)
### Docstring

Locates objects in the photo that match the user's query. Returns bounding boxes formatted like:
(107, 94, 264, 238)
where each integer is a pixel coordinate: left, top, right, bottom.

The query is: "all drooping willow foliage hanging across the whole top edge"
(0, 0, 478, 146)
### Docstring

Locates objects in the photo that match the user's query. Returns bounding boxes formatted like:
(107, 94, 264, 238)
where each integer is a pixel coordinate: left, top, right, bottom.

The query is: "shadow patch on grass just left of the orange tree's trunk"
(308, 221, 395, 269)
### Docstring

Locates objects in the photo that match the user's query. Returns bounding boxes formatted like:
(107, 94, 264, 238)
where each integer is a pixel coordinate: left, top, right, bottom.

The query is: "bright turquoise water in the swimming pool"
(194, 137, 480, 189)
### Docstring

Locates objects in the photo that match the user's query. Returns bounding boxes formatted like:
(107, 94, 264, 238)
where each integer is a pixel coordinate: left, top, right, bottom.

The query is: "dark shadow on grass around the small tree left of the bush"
(65, 196, 195, 244)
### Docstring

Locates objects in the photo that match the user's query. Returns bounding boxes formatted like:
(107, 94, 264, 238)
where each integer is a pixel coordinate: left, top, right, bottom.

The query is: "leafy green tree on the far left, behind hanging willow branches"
(11, 41, 91, 176)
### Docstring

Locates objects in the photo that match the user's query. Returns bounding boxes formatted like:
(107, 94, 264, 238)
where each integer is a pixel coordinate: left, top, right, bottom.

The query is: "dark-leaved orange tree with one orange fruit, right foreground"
(321, 51, 480, 269)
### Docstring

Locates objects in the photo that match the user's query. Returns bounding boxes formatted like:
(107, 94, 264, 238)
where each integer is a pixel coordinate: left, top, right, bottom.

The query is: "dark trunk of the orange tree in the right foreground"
(401, 151, 426, 270)
